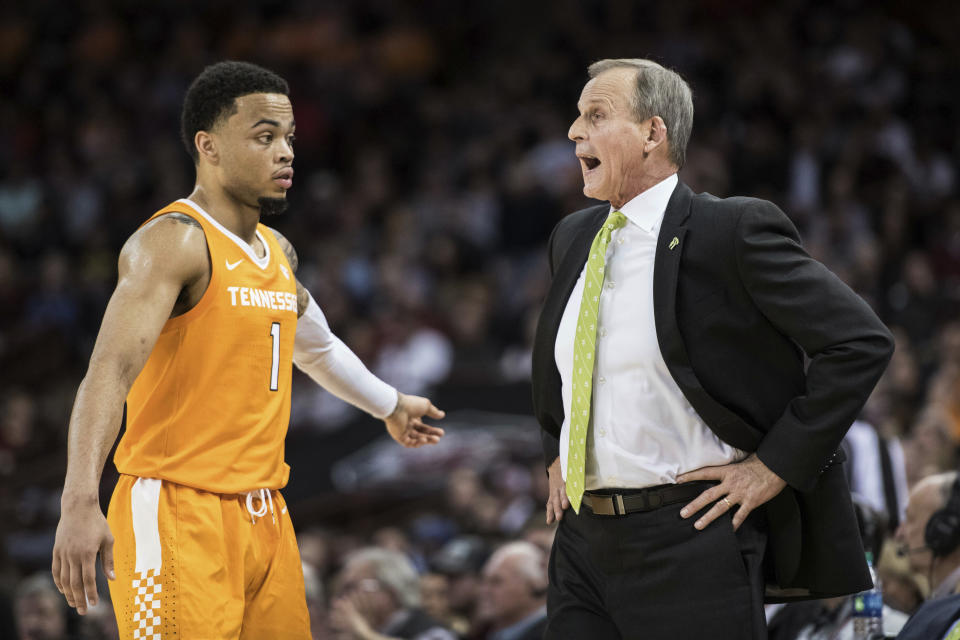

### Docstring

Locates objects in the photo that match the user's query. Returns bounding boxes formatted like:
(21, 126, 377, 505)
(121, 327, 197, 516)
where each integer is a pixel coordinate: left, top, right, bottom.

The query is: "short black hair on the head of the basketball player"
(180, 60, 290, 162)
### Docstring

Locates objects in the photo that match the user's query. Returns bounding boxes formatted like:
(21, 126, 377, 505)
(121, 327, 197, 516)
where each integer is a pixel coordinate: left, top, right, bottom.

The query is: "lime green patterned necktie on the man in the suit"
(567, 211, 627, 514)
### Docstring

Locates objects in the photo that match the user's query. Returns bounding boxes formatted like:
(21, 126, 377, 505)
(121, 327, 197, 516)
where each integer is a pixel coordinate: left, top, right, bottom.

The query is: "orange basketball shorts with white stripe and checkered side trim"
(107, 475, 310, 640)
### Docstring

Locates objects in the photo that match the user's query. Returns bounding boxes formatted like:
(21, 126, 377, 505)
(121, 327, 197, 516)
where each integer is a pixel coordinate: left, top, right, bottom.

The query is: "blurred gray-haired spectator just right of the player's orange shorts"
(330, 547, 456, 640)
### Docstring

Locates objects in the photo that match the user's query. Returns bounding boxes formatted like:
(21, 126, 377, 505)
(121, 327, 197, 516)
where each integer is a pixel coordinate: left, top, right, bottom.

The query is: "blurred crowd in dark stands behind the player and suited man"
(0, 0, 960, 638)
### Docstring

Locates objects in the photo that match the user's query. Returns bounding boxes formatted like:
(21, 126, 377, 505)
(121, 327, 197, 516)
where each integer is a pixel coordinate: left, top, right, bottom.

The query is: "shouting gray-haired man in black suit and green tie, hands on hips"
(533, 60, 893, 640)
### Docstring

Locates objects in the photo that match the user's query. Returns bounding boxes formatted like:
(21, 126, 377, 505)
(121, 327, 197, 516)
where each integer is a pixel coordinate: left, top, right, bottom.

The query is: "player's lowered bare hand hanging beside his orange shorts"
(52, 503, 114, 615)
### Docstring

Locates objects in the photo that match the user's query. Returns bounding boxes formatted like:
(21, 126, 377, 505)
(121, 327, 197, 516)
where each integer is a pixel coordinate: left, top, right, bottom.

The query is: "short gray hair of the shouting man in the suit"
(587, 58, 693, 168)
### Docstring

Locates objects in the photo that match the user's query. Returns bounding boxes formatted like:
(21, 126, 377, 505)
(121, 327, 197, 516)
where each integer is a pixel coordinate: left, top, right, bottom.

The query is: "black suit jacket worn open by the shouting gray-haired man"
(533, 183, 893, 601)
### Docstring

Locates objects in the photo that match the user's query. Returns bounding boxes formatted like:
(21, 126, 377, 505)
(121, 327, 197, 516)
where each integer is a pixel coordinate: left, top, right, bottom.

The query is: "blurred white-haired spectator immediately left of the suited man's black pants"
(477, 542, 547, 640)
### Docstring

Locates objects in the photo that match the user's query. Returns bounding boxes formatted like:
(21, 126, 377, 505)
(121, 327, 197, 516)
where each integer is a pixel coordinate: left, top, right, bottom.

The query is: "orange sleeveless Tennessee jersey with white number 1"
(114, 200, 297, 493)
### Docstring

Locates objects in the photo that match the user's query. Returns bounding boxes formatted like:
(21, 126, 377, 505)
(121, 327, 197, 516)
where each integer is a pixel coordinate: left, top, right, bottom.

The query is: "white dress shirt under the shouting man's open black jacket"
(554, 174, 746, 490)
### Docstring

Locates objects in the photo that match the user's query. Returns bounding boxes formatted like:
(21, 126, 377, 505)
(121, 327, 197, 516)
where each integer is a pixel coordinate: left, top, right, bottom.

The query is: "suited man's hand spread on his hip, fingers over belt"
(677, 453, 787, 530)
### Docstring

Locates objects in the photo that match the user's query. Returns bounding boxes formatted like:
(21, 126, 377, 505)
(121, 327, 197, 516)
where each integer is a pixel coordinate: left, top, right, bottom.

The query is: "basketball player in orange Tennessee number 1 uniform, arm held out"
(52, 62, 443, 639)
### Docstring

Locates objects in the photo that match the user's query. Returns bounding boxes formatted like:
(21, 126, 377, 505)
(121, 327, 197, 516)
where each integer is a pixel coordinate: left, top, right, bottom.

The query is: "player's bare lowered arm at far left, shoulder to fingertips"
(52, 214, 210, 614)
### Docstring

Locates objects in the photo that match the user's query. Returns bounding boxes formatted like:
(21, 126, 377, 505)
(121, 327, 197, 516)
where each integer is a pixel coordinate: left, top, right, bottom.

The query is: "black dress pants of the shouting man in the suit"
(544, 485, 767, 640)
